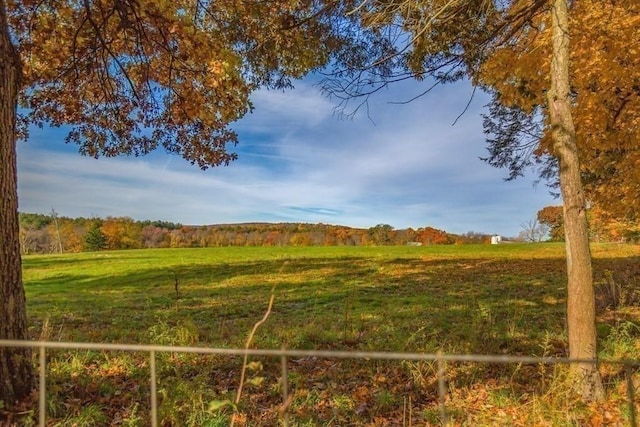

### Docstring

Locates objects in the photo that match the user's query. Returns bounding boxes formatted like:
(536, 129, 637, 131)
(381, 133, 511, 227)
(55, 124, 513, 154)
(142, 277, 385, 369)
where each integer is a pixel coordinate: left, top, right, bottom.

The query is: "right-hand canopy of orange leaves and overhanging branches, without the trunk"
(323, 0, 640, 219)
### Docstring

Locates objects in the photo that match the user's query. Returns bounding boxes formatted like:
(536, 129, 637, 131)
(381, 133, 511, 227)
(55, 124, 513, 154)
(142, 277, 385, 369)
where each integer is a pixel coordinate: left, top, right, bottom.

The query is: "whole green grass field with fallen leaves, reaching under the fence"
(13, 244, 640, 426)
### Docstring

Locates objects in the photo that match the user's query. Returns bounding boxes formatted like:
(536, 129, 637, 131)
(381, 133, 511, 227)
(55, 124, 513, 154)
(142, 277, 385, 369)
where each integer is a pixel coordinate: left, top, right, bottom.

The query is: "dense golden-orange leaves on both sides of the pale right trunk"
(475, 0, 640, 217)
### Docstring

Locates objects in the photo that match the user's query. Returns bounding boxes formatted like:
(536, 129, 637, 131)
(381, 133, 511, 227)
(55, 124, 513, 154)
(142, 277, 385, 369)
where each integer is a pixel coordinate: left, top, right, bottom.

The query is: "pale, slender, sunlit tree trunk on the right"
(547, 0, 604, 400)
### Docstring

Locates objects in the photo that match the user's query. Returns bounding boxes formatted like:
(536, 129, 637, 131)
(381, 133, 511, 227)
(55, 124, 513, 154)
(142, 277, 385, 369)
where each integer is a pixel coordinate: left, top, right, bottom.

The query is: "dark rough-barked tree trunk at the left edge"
(0, 0, 34, 407)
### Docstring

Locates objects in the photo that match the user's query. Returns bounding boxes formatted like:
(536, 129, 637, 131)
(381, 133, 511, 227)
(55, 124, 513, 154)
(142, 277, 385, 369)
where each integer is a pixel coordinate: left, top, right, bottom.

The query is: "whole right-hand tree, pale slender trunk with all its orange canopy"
(316, 0, 640, 399)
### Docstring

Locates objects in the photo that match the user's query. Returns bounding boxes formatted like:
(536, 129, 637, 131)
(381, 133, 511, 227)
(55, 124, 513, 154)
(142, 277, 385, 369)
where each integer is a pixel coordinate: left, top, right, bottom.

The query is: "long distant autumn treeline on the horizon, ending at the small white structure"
(20, 213, 491, 254)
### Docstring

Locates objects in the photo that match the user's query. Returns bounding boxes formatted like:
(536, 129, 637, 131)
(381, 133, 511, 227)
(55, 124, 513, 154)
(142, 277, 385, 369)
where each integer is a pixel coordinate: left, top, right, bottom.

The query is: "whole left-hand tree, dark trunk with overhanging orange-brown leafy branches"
(0, 0, 352, 406)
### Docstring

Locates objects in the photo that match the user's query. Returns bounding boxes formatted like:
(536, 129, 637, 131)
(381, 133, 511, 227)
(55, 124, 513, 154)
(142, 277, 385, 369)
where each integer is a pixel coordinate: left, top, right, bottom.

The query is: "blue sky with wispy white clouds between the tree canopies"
(13, 79, 559, 236)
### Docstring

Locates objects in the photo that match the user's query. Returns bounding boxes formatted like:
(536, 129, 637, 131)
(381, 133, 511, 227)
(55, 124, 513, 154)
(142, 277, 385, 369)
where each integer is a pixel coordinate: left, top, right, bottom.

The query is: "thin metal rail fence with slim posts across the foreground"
(0, 340, 640, 427)
